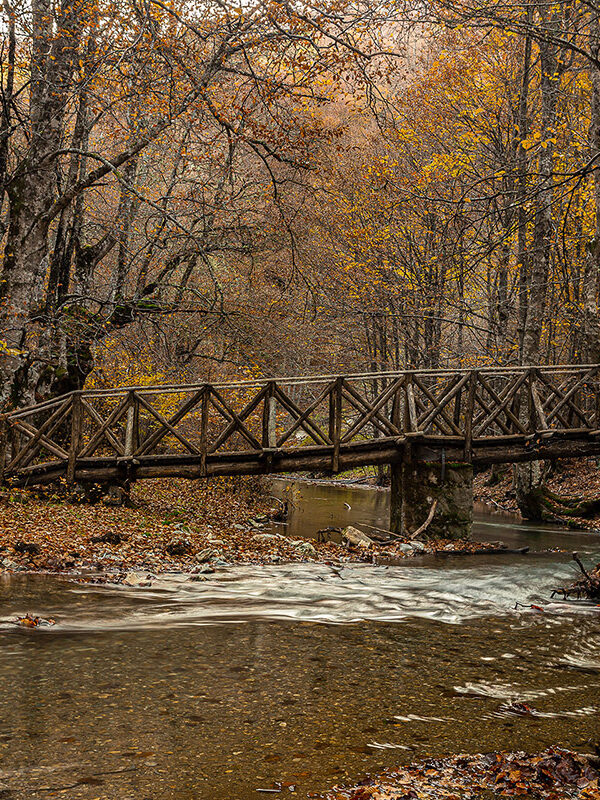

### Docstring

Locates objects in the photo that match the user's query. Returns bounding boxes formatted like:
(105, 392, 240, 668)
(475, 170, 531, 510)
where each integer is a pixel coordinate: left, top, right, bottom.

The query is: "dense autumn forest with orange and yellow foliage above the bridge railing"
(0, 0, 600, 400)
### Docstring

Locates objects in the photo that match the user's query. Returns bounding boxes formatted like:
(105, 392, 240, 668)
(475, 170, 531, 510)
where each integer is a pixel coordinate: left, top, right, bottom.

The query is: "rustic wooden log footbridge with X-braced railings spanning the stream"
(0, 365, 600, 486)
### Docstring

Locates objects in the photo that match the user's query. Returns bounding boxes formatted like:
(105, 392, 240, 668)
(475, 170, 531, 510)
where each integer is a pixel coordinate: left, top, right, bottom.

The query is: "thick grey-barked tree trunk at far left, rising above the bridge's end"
(0, 0, 83, 406)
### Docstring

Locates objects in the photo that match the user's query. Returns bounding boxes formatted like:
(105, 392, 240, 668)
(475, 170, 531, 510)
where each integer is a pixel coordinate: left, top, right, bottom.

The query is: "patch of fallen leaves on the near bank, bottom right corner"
(326, 748, 600, 800)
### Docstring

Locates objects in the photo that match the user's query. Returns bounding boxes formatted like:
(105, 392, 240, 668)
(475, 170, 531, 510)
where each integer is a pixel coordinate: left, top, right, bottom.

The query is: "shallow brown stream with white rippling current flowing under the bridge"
(0, 484, 600, 800)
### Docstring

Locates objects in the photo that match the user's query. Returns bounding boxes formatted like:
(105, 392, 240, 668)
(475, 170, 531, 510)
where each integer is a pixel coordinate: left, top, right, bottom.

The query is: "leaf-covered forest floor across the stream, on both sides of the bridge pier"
(0, 461, 600, 582)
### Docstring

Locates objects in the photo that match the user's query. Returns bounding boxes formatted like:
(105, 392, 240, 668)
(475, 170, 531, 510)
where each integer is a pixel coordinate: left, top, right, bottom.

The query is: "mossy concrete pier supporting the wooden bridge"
(390, 461, 473, 539)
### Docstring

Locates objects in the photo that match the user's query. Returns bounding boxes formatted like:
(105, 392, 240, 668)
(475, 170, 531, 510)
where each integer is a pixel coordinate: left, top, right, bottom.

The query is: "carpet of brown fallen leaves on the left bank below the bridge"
(0, 478, 356, 576)
